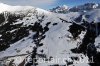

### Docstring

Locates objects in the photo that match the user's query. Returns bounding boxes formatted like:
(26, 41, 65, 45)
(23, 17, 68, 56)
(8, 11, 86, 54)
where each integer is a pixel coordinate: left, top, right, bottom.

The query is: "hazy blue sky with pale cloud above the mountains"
(0, 0, 100, 9)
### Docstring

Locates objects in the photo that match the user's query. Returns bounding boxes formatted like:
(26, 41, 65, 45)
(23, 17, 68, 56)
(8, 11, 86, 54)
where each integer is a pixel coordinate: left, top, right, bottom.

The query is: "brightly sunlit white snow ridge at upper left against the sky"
(0, 3, 47, 13)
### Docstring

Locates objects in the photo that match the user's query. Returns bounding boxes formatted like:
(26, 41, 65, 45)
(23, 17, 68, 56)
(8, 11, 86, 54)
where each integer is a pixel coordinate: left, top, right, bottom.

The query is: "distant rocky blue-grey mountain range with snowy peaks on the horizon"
(50, 3, 100, 13)
